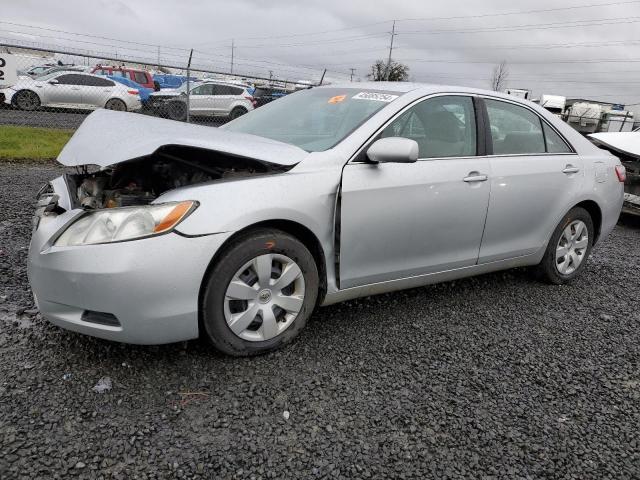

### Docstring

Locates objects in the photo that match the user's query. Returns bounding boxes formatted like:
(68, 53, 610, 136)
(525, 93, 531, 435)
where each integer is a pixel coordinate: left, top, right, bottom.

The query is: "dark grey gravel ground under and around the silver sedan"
(0, 164, 640, 479)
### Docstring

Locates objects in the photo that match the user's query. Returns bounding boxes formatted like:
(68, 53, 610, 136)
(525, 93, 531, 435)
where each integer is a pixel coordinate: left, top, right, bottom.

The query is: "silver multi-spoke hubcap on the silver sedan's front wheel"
(224, 254, 305, 342)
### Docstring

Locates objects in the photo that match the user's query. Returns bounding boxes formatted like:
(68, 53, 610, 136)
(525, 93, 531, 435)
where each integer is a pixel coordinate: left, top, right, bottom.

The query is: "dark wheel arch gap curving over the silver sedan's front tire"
(198, 219, 327, 331)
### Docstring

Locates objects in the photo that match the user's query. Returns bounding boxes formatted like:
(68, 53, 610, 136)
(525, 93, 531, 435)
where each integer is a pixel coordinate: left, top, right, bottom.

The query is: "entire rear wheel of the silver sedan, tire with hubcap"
(536, 207, 594, 285)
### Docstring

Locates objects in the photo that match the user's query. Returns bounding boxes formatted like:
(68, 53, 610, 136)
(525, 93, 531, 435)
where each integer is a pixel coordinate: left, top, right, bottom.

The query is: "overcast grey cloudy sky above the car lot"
(0, 0, 640, 110)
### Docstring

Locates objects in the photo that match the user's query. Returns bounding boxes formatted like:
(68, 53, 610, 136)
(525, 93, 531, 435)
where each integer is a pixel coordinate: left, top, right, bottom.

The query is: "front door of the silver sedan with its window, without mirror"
(340, 96, 491, 288)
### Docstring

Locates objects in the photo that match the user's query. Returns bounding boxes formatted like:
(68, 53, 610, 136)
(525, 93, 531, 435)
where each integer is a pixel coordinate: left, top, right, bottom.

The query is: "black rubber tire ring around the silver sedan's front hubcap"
(201, 231, 319, 356)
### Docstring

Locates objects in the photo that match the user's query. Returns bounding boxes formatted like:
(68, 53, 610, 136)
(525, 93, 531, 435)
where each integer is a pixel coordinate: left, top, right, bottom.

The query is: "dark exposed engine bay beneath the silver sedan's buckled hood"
(66, 145, 291, 209)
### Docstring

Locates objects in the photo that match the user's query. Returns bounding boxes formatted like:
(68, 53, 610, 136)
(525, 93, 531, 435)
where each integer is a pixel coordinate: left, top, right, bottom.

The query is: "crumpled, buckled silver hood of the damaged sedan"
(58, 109, 308, 167)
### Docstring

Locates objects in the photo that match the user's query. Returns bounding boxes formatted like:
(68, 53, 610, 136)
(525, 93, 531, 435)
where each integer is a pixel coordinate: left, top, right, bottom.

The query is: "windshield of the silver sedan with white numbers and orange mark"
(224, 88, 399, 152)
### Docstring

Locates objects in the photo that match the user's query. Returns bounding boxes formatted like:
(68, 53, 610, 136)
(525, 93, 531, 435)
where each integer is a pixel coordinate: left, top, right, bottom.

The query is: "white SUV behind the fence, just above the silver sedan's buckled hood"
(149, 81, 255, 120)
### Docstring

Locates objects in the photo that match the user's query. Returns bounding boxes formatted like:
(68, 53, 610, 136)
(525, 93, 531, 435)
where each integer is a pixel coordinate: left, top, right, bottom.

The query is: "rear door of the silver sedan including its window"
(479, 98, 584, 263)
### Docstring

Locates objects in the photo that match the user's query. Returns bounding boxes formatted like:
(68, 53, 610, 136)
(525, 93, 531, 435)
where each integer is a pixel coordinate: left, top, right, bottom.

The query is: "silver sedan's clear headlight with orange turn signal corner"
(55, 202, 198, 247)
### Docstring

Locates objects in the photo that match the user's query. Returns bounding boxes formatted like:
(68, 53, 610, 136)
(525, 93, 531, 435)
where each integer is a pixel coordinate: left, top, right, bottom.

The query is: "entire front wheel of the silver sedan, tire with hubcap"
(200, 230, 319, 356)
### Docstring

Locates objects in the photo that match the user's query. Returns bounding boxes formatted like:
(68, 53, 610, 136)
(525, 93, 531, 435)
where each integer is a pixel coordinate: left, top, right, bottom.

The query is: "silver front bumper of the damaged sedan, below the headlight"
(28, 212, 229, 344)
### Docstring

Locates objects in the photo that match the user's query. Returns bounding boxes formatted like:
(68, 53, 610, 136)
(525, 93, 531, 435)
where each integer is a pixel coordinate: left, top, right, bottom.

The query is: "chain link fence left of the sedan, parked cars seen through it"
(0, 43, 318, 129)
